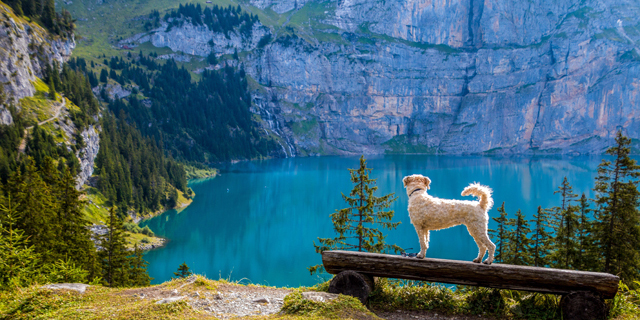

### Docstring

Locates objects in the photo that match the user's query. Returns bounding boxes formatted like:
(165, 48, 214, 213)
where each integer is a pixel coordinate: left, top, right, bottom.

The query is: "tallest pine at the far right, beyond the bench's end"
(593, 131, 640, 282)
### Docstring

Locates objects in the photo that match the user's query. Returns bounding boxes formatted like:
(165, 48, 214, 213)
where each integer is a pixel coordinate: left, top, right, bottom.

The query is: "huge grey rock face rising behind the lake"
(130, 0, 640, 155)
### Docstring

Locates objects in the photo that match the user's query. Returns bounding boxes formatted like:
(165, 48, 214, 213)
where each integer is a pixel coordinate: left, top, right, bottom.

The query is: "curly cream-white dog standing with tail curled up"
(402, 174, 496, 264)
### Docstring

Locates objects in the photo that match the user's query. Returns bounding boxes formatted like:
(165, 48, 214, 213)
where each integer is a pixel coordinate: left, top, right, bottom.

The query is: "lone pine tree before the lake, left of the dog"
(309, 156, 402, 274)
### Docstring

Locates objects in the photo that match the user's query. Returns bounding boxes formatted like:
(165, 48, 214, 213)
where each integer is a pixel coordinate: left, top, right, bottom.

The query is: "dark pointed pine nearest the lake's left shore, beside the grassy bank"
(99, 207, 129, 287)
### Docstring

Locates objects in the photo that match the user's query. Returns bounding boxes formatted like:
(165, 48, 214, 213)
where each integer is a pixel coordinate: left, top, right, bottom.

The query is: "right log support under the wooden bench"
(560, 291, 607, 320)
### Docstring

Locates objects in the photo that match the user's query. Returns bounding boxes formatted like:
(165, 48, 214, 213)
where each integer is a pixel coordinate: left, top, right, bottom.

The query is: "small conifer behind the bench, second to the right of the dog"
(505, 209, 531, 266)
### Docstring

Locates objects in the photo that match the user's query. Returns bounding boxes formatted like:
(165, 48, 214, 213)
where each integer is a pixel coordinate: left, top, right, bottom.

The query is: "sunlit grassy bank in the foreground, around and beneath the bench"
(0, 276, 640, 319)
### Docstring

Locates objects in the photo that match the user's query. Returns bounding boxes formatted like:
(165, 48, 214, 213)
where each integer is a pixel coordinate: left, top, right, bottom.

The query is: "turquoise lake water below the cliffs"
(141, 155, 602, 287)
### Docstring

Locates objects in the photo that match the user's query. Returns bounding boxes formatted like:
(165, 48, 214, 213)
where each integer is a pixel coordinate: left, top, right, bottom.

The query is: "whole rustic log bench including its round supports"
(322, 250, 620, 320)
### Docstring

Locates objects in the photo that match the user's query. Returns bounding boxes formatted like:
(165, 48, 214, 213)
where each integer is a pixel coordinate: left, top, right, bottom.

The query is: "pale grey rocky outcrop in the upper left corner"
(0, 5, 76, 124)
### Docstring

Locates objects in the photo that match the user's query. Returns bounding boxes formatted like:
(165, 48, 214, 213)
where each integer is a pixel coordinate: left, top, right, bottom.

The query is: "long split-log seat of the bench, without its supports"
(322, 251, 620, 299)
